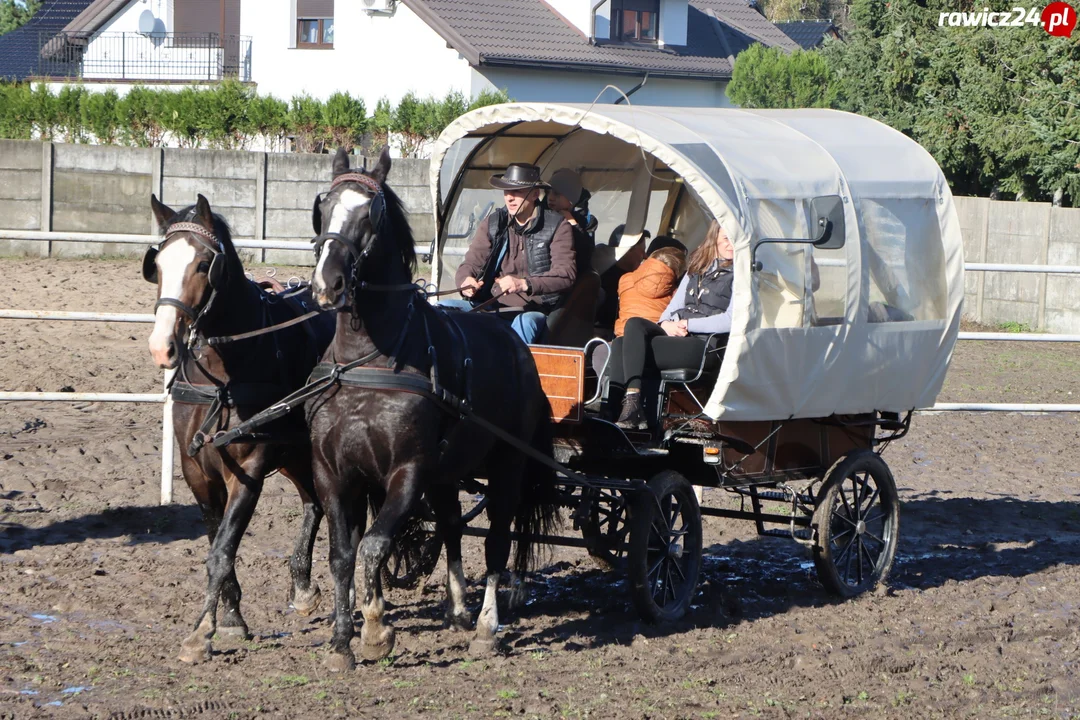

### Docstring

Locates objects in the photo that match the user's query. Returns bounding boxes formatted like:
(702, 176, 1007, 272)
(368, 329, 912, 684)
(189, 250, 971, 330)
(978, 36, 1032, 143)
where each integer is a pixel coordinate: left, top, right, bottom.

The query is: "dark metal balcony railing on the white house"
(38, 32, 252, 82)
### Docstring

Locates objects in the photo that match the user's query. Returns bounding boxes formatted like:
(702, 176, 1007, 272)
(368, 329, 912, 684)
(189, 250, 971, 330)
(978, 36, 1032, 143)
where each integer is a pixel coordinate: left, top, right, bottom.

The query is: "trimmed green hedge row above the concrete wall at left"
(0, 81, 509, 157)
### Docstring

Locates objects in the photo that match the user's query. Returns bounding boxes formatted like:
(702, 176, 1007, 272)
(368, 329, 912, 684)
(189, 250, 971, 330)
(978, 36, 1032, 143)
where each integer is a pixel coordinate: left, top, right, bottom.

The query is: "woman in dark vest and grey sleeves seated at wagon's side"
(609, 220, 734, 430)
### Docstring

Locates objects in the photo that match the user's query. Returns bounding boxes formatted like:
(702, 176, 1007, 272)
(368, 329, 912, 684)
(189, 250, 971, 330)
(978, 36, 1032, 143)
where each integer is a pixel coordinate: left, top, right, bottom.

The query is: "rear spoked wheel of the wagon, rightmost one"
(812, 450, 900, 597)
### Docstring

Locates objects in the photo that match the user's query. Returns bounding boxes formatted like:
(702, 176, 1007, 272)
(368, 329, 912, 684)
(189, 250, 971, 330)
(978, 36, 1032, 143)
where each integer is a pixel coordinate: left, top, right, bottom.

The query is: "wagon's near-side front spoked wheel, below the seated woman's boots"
(629, 471, 701, 623)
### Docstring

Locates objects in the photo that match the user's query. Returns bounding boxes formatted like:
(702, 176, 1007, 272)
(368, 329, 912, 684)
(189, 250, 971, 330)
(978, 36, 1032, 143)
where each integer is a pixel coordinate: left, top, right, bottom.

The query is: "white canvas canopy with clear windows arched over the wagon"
(431, 103, 963, 420)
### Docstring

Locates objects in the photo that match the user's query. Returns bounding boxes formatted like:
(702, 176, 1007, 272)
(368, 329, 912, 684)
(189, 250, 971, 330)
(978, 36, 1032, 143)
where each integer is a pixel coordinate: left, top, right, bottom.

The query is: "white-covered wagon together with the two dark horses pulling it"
(144, 104, 963, 669)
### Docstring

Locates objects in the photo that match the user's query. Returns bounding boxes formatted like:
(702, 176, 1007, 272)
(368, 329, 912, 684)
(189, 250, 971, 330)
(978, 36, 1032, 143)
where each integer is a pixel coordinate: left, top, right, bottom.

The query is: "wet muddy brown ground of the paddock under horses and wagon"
(0, 260, 1080, 718)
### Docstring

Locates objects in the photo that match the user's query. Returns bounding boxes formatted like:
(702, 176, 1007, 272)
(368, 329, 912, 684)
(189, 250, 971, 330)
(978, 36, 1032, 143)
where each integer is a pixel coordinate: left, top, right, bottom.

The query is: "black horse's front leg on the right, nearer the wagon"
(360, 464, 421, 662)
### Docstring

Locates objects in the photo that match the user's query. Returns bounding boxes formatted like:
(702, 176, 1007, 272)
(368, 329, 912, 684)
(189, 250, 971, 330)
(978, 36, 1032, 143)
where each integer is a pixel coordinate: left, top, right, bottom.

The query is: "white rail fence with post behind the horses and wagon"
(0, 229, 1080, 505)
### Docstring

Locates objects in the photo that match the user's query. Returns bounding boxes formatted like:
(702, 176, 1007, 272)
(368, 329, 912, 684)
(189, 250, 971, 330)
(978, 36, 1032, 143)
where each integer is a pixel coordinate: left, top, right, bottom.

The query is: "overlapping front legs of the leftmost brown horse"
(180, 465, 262, 663)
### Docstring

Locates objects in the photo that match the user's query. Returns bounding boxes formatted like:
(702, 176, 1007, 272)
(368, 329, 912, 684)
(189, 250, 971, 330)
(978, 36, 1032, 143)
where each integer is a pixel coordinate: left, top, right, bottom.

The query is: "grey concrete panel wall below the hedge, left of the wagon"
(0, 140, 435, 264)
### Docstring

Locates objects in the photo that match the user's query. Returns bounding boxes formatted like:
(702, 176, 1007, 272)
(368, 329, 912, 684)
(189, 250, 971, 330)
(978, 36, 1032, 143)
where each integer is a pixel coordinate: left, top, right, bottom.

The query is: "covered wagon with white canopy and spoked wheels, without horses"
(421, 104, 963, 621)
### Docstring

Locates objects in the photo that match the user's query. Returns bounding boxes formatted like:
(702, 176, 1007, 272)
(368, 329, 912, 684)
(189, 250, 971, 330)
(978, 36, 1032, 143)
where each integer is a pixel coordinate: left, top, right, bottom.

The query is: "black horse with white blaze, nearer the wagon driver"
(308, 150, 557, 670)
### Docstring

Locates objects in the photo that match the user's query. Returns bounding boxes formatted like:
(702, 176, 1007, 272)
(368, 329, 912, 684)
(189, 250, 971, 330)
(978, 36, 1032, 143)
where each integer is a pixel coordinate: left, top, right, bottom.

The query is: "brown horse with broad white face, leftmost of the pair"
(143, 195, 333, 663)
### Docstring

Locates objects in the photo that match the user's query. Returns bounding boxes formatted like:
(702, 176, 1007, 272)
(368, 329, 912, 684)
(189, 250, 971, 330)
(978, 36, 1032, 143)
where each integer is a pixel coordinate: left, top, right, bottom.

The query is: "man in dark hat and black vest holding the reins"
(446, 163, 577, 342)
